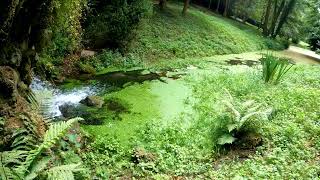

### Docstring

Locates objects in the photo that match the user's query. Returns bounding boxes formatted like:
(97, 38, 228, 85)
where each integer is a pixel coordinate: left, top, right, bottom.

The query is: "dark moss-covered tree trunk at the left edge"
(0, 0, 51, 149)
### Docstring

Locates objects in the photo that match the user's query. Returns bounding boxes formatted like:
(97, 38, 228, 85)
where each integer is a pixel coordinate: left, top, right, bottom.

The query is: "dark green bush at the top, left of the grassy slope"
(84, 0, 150, 49)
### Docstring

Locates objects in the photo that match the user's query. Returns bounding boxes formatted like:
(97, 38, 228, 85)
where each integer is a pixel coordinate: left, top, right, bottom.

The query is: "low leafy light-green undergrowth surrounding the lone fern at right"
(80, 65, 320, 179)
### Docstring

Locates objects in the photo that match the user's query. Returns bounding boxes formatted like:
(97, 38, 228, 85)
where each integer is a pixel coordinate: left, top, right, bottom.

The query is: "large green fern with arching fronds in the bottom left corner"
(0, 118, 82, 180)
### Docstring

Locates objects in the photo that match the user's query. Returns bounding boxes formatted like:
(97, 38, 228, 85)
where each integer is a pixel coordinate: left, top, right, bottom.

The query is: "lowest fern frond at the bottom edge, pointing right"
(48, 163, 82, 180)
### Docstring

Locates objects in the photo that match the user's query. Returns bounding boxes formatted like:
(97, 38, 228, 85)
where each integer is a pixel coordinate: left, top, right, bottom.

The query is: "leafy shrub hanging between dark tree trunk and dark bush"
(35, 0, 86, 79)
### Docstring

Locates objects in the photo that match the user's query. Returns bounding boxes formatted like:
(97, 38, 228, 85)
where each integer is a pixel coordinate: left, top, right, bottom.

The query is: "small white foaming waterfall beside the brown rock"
(30, 77, 97, 118)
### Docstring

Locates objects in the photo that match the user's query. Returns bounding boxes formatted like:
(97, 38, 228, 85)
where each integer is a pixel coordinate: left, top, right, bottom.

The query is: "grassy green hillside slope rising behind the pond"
(130, 4, 282, 61)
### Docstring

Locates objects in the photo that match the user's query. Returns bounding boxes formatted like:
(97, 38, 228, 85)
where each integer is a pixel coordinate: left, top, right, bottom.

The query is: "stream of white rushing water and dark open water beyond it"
(30, 69, 185, 119)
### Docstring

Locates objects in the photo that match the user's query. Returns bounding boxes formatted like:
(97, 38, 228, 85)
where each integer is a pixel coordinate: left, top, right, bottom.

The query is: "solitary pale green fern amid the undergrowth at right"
(217, 91, 272, 145)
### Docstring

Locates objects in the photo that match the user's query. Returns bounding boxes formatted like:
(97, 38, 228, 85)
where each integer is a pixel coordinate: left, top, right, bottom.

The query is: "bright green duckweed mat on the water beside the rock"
(83, 80, 191, 145)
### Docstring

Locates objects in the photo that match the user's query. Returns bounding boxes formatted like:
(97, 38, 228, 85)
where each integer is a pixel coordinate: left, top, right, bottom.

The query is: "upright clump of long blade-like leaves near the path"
(261, 54, 293, 84)
